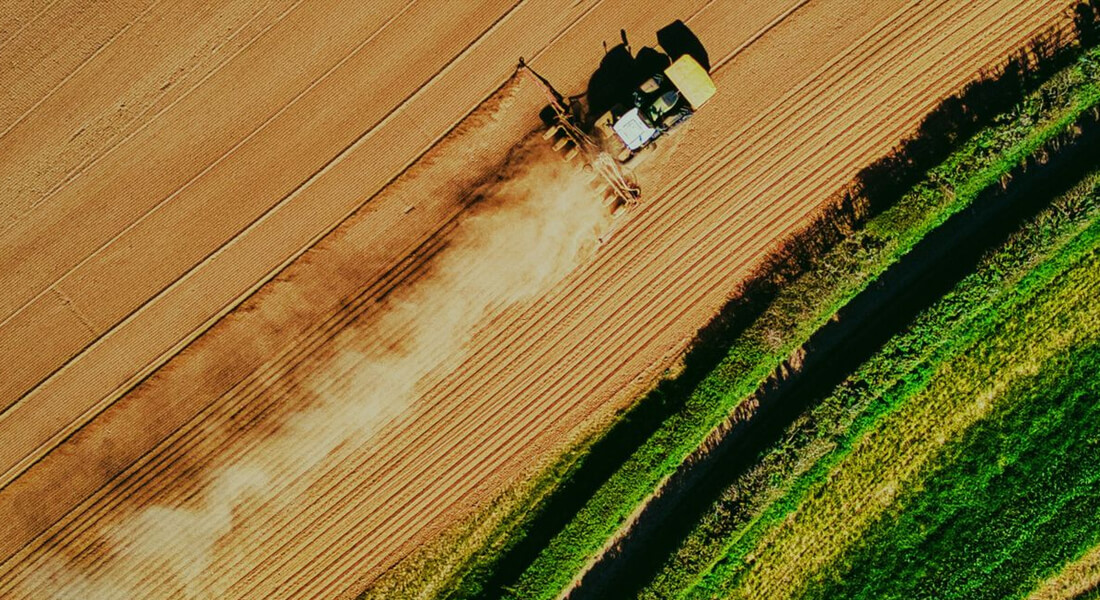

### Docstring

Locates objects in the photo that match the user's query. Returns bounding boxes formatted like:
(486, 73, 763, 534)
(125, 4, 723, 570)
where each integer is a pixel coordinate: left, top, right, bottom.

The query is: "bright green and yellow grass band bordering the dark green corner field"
(688, 182, 1100, 598)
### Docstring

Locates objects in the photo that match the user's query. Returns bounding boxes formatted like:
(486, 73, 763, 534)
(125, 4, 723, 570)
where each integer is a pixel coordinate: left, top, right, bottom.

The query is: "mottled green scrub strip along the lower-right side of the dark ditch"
(642, 161, 1100, 598)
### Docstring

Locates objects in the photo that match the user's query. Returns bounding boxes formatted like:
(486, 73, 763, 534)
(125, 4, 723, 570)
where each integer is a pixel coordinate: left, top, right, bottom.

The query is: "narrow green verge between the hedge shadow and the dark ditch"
(497, 44, 1100, 599)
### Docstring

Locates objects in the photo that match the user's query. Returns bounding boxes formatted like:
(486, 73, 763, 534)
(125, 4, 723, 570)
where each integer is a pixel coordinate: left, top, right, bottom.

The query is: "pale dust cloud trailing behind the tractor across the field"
(21, 147, 607, 599)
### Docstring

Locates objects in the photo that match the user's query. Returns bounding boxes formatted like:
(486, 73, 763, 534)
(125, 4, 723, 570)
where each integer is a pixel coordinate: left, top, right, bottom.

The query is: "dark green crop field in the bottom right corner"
(800, 346, 1100, 600)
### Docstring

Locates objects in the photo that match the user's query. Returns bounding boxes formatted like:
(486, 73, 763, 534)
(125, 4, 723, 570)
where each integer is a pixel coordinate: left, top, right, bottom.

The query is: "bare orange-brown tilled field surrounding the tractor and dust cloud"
(0, 0, 1066, 597)
